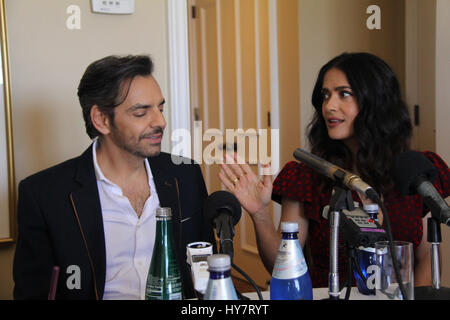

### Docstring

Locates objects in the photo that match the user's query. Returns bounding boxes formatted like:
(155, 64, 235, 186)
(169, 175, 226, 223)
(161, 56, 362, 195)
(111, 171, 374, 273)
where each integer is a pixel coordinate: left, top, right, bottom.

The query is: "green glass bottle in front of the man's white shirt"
(145, 208, 183, 300)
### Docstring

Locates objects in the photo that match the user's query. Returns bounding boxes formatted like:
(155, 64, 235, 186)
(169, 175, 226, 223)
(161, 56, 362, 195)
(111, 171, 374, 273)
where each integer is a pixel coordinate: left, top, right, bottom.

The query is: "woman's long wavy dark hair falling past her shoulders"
(308, 53, 412, 193)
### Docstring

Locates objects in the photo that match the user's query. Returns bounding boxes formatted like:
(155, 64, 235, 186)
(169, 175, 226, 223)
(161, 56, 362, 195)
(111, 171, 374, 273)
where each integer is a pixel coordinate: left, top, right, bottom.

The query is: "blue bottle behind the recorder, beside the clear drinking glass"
(353, 203, 378, 295)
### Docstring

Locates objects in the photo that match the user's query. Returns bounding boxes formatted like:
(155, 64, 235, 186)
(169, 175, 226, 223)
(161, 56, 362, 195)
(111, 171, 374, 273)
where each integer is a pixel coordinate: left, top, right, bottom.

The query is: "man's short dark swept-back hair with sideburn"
(78, 55, 153, 139)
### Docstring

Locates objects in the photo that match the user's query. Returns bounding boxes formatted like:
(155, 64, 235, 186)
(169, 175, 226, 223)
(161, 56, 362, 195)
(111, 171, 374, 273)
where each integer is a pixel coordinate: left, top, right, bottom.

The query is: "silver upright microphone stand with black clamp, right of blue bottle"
(328, 186, 354, 300)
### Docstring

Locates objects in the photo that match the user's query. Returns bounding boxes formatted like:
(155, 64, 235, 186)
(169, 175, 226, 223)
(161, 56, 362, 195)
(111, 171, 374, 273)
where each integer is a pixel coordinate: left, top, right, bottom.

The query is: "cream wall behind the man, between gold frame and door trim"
(0, 0, 170, 299)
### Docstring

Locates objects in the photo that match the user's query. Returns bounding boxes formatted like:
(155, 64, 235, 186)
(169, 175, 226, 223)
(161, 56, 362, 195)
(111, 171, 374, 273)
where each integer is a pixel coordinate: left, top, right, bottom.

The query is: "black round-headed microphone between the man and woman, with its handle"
(204, 190, 242, 261)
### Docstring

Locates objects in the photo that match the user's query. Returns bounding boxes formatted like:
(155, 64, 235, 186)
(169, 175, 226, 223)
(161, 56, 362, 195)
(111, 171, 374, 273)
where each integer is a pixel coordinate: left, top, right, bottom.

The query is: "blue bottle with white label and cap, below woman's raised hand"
(270, 222, 313, 300)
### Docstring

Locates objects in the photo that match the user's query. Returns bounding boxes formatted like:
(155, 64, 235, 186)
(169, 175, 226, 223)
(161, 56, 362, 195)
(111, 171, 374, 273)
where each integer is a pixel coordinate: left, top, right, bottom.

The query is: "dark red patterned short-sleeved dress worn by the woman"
(272, 151, 450, 288)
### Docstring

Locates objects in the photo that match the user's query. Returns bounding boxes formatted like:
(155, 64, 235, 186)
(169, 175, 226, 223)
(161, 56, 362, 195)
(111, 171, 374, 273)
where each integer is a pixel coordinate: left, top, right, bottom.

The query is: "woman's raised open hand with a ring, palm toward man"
(219, 153, 272, 218)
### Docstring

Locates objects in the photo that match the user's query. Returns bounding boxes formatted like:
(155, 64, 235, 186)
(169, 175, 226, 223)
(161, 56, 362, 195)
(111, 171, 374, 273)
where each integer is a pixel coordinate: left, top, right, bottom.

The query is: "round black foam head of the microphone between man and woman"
(203, 190, 242, 225)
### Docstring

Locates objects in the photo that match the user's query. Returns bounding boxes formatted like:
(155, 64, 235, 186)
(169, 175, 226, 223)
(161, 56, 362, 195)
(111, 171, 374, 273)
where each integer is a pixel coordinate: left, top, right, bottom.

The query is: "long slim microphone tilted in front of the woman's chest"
(294, 148, 379, 202)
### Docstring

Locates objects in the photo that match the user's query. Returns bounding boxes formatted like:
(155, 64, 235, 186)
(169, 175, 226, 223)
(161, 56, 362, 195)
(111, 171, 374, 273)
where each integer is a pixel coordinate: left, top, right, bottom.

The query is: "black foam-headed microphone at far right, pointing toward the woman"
(392, 151, 450, 226)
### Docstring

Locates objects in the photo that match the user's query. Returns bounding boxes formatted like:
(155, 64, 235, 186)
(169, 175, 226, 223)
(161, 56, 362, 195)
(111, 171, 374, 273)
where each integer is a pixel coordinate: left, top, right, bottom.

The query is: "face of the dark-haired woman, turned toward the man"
(321, 68, 359, 148)
